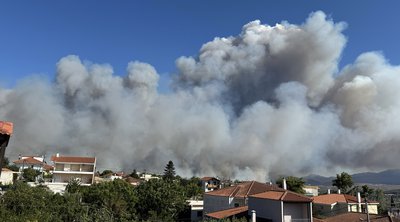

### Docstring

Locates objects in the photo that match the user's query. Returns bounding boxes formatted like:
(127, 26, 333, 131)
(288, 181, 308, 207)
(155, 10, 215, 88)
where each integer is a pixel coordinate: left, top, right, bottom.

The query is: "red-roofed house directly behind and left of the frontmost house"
(204, 181, 283, 214)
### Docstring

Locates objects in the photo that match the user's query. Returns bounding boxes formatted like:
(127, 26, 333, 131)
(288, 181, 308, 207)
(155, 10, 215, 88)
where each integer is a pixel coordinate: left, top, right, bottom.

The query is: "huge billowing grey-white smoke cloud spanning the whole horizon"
(0, 12, 400, 180)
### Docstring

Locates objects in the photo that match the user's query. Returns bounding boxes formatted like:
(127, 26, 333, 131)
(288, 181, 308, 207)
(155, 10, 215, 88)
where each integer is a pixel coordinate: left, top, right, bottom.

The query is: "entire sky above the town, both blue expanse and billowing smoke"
(0, 0, 400, 180)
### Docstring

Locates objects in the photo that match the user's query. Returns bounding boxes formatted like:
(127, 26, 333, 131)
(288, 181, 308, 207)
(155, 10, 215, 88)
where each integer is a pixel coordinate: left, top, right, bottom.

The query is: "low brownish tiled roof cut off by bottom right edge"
(313, 212, 392, 222)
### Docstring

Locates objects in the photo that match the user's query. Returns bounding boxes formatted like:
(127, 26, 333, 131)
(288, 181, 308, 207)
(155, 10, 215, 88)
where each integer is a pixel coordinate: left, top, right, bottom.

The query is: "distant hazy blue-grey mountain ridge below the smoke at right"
(303, 169, 400, 186)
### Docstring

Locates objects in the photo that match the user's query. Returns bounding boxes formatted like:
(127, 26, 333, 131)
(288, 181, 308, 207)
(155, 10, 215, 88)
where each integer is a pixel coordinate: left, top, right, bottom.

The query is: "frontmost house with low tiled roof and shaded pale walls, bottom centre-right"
(248, 190, 313, 222)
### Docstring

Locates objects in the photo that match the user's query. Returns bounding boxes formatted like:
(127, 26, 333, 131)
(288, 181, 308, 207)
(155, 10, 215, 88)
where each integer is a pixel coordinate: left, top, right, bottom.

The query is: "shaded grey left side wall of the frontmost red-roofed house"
(249, 197, 282, 222)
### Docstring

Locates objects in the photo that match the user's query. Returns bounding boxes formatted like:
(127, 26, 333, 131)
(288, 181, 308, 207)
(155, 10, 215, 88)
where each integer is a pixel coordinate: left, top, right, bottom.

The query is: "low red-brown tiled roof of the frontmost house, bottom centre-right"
(250, 190, 312, 203)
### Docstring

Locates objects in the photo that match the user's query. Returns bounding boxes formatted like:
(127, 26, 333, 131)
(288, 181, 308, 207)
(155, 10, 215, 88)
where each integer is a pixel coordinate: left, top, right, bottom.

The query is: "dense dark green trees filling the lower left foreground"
(0, 160, 201, 222)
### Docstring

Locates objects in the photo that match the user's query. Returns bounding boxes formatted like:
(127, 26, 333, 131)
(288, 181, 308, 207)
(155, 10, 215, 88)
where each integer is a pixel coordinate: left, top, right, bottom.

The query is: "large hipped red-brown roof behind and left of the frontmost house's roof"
(204, 181, 285, 198)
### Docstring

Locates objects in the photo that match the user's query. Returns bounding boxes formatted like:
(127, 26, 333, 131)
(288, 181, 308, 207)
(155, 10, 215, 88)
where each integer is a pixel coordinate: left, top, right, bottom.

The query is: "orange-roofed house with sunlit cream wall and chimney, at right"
(312, 193, 379, 216)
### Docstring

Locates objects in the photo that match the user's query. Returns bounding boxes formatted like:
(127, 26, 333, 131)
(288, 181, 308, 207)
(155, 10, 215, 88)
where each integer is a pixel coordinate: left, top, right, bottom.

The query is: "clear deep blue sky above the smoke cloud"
(0, 0, 400, 91)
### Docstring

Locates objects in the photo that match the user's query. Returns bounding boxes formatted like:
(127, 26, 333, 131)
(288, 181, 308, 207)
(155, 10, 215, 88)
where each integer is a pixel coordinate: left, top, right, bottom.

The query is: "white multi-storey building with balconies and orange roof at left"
(51, 154, 96, 185)
